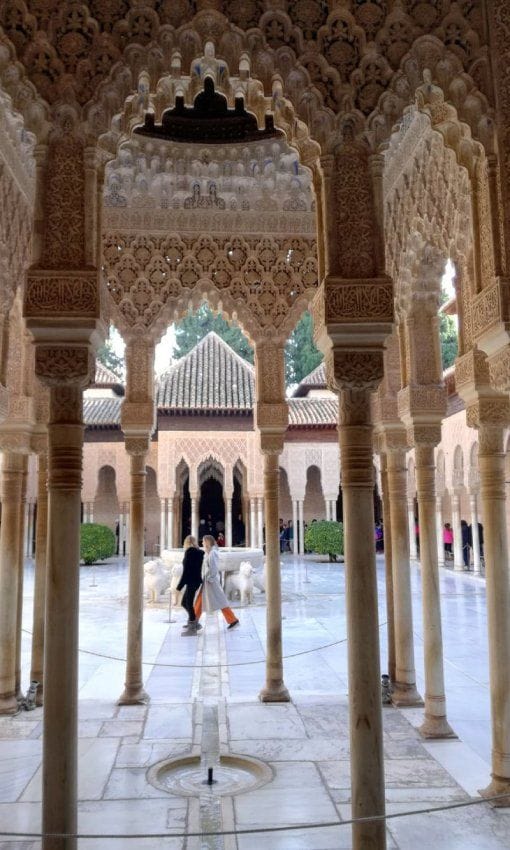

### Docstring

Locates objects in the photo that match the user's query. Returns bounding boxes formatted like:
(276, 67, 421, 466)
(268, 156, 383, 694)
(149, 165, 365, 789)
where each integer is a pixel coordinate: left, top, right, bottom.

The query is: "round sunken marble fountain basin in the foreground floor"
(147, 755, 273, 797)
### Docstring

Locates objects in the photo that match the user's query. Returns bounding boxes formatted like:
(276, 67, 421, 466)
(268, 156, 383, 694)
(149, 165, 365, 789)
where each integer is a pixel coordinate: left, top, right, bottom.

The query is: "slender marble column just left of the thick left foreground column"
(30, 454, 48, 705)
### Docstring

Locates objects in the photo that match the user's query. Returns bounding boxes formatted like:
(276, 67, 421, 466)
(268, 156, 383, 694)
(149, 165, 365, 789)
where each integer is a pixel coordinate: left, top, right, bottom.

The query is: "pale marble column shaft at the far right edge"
(478, 425, 510, 806)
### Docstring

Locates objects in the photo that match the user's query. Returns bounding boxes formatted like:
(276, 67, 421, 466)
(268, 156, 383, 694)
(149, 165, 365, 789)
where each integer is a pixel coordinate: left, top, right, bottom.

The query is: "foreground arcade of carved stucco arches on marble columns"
(0, 0, 510, 850)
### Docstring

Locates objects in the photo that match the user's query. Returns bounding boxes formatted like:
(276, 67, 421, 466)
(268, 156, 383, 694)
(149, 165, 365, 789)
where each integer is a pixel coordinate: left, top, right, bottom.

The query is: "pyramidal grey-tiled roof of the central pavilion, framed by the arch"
(156, 331, 255, 411)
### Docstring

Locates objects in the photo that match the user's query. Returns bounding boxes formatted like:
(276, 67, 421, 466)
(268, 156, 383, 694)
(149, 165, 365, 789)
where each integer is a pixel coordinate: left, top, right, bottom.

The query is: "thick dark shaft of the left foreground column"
(42, 386, 83, 850)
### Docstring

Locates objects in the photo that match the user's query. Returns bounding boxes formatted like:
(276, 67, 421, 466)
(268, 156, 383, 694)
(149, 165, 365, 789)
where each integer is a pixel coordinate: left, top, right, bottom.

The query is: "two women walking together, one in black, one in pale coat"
(177, 534, 239, 637)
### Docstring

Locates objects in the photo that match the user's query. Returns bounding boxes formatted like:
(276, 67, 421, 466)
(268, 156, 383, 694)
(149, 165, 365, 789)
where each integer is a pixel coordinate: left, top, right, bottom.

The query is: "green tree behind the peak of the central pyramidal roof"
(173, 304, 253, 363)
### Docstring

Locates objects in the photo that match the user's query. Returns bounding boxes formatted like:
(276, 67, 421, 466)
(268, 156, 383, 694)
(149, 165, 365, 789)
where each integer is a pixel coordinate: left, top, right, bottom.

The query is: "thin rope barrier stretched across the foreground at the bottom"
(0, 794, 510, 841)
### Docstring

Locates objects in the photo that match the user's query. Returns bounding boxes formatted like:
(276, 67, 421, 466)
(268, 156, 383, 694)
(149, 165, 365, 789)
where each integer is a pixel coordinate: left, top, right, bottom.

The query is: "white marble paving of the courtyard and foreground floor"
(0, 556, 510, 850)
